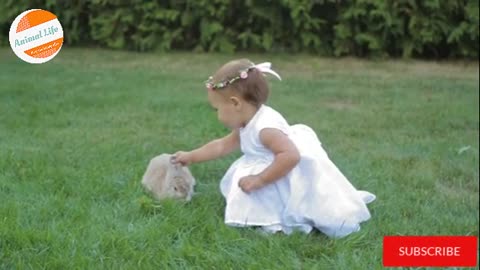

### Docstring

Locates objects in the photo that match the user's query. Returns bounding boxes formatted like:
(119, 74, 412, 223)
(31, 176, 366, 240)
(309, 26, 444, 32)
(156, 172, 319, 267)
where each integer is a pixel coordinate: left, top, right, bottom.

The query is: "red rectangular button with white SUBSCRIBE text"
(383, 236, 478, 267)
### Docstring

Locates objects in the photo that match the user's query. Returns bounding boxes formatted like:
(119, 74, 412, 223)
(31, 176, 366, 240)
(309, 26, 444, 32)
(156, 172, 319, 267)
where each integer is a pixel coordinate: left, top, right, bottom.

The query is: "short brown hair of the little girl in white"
(212, 59, 269, 108)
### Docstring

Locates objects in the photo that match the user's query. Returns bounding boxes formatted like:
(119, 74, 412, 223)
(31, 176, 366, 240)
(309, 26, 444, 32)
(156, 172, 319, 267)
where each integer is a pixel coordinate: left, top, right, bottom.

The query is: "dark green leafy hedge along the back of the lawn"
(0, 0, 479, 59)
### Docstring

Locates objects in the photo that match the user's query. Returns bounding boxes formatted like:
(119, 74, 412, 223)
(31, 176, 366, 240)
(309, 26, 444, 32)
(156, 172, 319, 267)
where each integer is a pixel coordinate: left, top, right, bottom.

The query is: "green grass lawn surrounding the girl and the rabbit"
(0, 48, 479, 269)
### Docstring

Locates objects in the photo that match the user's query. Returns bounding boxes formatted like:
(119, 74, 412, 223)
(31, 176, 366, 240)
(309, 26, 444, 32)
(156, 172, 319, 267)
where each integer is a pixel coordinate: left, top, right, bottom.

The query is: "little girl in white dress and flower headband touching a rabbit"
(173, 59, 375, 237)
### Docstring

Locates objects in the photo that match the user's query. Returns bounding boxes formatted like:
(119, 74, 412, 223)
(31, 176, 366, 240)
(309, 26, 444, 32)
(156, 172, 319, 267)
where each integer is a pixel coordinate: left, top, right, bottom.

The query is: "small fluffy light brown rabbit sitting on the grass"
(142, 154, 195, 201)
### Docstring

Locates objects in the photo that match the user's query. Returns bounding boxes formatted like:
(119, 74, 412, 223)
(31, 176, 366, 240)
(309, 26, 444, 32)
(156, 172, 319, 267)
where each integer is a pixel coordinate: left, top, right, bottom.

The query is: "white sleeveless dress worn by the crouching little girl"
(220, 105, 375, 237)
